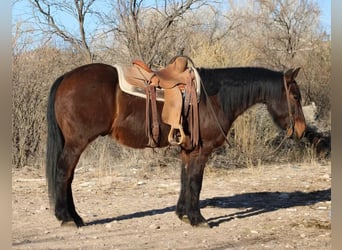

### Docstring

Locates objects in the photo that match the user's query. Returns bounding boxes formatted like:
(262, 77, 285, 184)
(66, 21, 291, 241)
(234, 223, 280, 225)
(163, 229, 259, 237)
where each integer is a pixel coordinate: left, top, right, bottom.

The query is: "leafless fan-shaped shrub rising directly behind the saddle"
(112, 0, 205, 65)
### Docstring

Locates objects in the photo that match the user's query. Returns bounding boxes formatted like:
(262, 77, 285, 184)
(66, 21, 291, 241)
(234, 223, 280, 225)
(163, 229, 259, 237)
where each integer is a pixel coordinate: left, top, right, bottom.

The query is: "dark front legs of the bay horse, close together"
(176, 150, 208, 226)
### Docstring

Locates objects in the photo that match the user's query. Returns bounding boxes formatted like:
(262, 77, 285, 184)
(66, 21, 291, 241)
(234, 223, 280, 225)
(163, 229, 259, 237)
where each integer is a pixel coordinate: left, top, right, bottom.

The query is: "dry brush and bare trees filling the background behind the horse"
(12, 0, 331, 171)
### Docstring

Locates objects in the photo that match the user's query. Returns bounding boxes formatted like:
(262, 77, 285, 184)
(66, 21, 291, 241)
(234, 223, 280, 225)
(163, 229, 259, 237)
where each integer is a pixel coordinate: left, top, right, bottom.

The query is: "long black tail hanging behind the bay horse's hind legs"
(46, 76, 64, 207)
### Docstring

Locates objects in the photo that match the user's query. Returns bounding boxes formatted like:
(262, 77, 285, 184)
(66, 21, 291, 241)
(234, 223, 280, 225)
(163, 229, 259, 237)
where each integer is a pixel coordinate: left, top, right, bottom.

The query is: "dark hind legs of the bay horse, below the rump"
(55, 143, 84, 227)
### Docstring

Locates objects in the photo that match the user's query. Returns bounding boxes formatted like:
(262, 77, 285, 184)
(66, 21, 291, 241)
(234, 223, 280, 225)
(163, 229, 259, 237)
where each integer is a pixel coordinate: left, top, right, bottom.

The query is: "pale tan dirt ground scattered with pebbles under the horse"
(12, 163, 331, 250)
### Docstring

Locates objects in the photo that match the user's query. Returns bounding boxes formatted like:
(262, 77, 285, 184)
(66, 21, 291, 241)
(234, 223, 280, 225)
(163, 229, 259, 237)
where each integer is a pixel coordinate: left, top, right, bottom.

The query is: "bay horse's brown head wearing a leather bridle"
(267, 68, 306, 139)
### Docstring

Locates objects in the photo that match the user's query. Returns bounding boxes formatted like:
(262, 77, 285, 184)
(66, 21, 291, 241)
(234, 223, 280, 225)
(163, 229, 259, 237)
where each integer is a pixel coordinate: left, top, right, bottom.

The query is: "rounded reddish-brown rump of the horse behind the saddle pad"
(55, 64, 118, 143)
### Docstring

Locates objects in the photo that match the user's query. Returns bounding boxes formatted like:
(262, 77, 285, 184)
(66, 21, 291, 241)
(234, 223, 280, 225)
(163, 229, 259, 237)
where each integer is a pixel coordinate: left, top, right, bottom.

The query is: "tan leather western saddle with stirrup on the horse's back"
(122, 56, 199, 147)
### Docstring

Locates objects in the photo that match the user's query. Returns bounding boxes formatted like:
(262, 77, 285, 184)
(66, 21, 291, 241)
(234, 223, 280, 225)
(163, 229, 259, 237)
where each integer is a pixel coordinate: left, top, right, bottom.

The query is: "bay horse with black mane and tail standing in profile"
(46, 59, 306, 227)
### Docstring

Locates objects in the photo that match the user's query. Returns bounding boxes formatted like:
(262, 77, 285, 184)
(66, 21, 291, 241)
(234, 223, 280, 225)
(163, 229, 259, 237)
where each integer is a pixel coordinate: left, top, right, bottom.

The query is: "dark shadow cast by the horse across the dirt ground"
(87, 188, 331, 227)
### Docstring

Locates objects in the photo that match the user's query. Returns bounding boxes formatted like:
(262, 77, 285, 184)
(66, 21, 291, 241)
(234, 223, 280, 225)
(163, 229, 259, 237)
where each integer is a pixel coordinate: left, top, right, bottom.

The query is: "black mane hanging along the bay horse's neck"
(198, 67, 283, 114)
